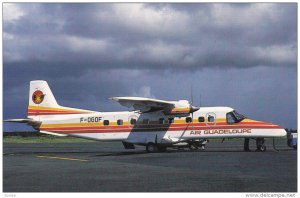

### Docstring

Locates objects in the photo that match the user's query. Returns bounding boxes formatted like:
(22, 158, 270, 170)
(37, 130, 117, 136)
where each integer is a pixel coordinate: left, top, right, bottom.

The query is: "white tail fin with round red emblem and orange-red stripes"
(28, 80, 93, 118)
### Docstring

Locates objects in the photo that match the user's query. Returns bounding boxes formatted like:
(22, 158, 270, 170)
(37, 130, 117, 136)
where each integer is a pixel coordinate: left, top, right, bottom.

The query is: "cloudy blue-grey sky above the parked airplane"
(3, 3, 297, 130)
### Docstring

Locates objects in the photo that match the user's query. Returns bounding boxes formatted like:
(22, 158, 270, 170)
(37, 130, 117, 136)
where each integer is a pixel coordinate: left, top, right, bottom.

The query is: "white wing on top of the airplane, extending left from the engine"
(110, 97, 175, 113)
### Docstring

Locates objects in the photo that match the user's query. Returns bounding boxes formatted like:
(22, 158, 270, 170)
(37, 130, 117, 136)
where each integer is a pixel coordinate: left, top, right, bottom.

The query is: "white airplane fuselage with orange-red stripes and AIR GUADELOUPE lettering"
(34, 107, 286, 145)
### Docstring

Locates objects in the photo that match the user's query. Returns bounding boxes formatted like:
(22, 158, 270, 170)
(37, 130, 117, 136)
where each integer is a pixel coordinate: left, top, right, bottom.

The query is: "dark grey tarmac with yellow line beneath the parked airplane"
(3, 140, 297, 192)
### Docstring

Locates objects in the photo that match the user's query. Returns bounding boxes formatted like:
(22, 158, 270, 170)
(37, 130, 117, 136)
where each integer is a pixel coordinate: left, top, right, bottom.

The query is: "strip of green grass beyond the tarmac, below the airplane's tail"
(3, 135, 95, 144)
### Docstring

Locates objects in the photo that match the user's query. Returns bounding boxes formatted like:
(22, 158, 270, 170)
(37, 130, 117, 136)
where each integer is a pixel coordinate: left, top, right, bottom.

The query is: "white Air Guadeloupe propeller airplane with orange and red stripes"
(4, 80, 286, 152)
